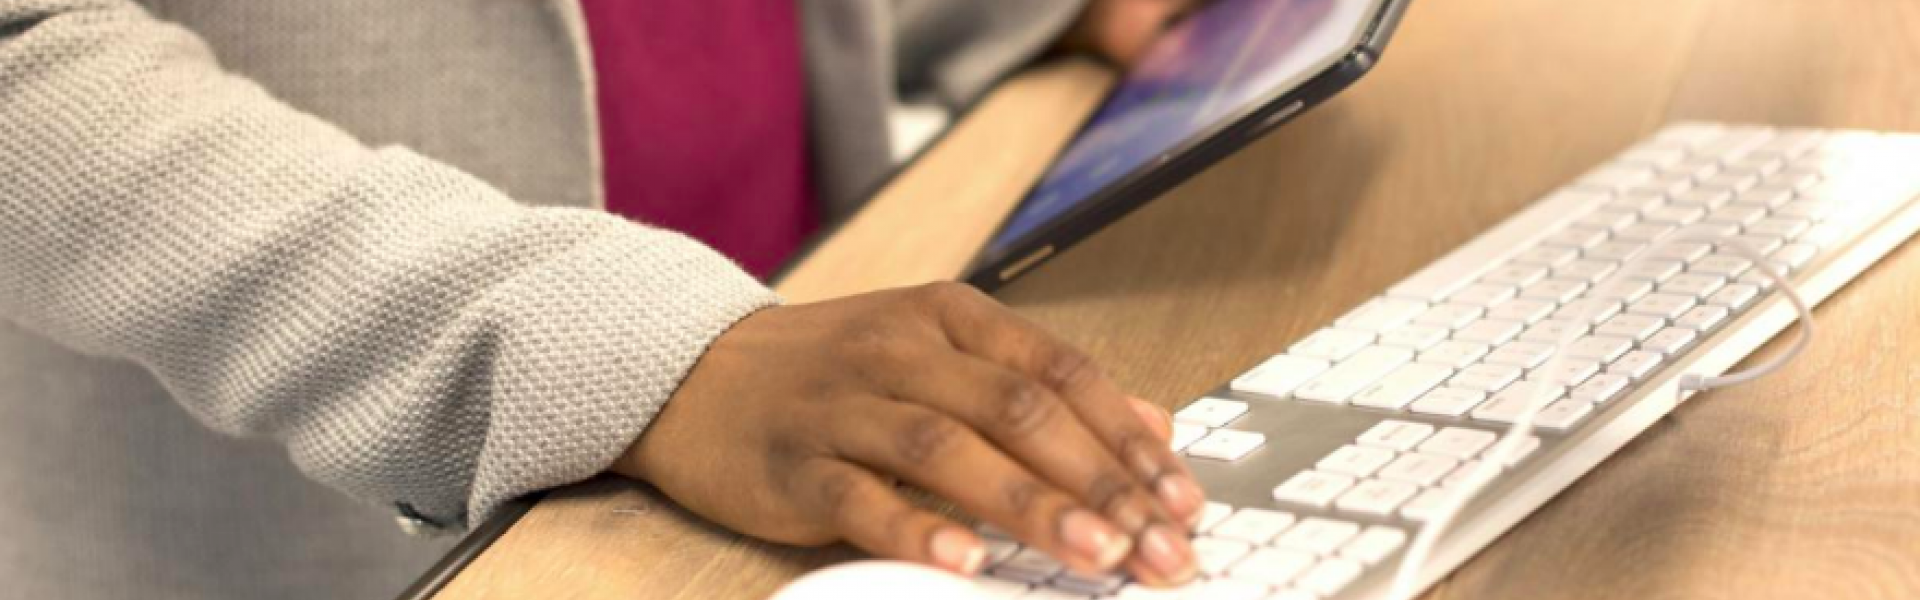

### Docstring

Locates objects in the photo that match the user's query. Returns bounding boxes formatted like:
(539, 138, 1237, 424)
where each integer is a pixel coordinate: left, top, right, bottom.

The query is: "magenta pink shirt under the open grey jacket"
(582, 0, 820, 277)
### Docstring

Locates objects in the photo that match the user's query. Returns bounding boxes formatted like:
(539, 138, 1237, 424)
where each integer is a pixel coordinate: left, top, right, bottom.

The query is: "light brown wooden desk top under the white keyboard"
(442, 0, 1920, 598)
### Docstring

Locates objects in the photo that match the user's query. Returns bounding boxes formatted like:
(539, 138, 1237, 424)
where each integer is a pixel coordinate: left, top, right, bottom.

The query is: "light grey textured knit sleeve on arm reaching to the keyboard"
(0, 0, 778, 527)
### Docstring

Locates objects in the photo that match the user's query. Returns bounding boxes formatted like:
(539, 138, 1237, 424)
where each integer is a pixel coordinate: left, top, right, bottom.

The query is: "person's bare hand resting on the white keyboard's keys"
(614, 283, 1204, 585)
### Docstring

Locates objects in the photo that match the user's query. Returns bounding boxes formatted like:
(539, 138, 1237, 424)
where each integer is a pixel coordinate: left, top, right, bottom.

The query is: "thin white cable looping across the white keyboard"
(1386, 233, 1812, 600)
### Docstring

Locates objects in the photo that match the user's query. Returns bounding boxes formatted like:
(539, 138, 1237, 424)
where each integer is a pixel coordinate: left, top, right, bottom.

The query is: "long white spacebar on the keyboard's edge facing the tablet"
(1386, 187, 1594, 302)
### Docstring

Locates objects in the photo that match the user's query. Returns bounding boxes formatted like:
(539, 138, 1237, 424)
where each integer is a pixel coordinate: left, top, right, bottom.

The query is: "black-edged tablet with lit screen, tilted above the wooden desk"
(966, 0, 1409, 290)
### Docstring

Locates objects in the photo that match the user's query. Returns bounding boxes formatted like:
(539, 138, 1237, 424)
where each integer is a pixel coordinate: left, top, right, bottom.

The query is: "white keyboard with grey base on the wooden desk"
(981, 123, 1920, 600)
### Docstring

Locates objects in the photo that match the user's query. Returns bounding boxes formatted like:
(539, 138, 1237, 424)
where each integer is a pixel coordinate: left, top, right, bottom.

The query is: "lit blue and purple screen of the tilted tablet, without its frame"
(987, 0, 1379, 256)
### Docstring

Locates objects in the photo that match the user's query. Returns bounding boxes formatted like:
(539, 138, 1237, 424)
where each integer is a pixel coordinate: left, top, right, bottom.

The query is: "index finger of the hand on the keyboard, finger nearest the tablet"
(910, 285, 1206, 523)
